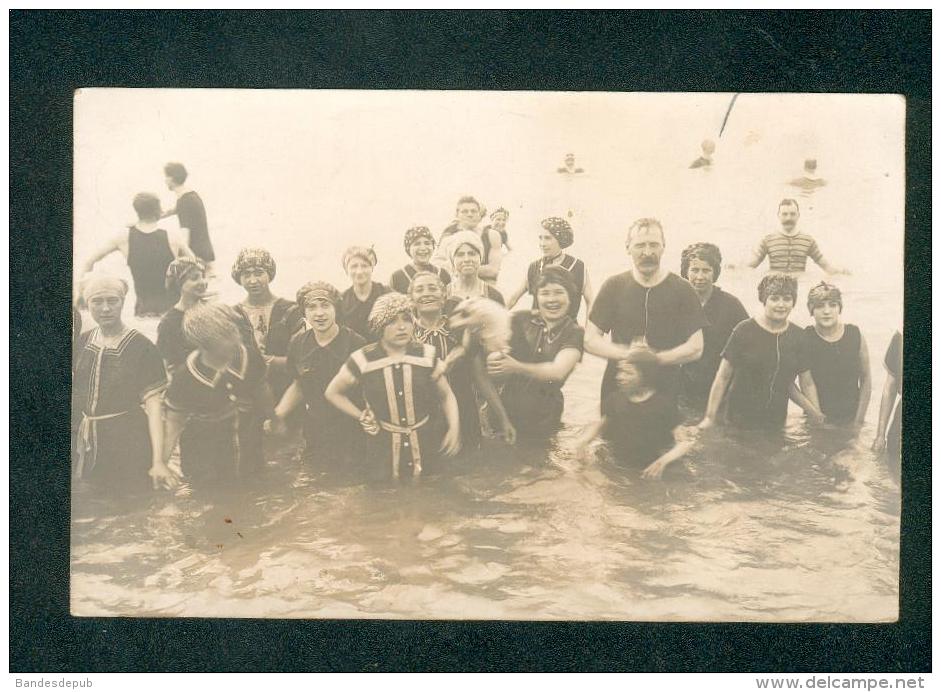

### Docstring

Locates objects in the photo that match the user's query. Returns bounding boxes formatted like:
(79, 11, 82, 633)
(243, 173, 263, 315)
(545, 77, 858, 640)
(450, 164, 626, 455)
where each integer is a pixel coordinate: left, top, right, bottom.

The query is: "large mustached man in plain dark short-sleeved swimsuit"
(585, 218, 707, 415)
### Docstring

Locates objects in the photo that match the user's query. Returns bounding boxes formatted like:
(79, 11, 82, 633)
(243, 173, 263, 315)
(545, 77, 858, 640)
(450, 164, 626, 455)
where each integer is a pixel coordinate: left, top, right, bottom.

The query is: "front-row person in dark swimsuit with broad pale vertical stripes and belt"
(326, 293, 461, 480)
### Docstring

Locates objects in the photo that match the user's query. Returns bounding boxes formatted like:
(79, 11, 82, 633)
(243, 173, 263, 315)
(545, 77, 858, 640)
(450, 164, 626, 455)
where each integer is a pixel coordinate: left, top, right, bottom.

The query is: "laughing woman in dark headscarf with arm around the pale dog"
(487, 266, 585, 440)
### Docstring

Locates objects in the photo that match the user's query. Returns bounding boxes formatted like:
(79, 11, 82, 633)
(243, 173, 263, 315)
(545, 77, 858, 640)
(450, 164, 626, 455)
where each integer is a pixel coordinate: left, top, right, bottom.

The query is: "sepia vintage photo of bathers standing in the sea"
(70, 89, 906, 622)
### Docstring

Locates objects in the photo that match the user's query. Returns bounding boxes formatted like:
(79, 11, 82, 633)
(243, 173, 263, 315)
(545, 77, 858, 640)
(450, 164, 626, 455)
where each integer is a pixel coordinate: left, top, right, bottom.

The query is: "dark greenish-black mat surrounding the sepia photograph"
(10, 11, 931, 672)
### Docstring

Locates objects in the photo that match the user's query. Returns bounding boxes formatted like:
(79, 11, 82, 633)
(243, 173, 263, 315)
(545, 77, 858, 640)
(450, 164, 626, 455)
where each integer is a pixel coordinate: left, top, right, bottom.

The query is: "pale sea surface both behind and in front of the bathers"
(63, 90, 904, 622)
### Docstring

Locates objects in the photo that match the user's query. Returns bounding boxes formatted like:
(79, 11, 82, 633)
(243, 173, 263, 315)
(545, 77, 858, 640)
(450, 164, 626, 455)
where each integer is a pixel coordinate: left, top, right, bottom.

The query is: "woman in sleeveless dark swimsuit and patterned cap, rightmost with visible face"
(804, 281, 872, 428)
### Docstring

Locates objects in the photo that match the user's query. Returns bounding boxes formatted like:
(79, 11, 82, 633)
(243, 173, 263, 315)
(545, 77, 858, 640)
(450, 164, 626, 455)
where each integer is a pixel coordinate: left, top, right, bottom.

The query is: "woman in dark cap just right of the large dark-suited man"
(680, 243, 748, 416)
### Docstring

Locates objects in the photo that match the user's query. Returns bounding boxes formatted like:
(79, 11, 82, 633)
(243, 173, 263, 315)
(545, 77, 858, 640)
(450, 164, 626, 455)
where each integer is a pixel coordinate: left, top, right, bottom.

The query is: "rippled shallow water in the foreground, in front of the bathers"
(72, 346, 899, 621)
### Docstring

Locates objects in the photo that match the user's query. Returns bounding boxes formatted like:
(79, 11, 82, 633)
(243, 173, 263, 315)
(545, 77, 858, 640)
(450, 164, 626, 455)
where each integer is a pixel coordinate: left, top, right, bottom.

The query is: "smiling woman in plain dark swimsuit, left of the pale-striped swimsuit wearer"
(272, 281, 366, 467)
